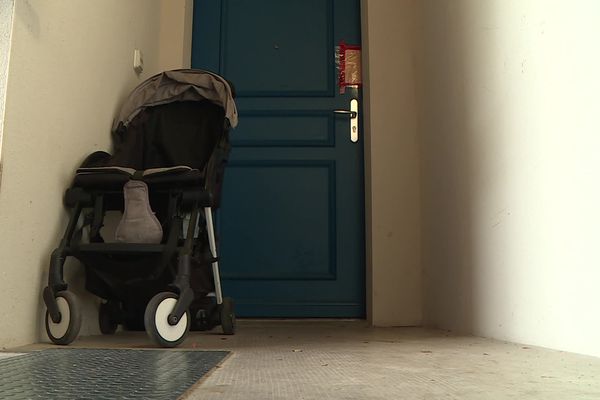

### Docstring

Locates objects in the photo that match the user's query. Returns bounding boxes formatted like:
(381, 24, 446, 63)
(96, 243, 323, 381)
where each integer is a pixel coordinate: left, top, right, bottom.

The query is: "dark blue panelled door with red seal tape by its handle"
(192, 0, 365, 317)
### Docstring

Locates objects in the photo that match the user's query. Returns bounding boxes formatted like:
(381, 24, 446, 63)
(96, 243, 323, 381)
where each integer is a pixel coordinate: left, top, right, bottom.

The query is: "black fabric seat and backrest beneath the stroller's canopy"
(74, 101, 230, 208)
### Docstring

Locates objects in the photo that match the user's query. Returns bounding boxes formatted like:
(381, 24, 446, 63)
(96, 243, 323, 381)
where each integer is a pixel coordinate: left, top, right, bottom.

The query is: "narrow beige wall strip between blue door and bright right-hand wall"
(362, 0, 422, 326)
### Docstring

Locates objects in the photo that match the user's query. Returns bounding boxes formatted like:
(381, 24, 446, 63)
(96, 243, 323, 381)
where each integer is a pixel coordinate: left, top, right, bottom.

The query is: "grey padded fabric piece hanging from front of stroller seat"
(115, 180, 163, 243)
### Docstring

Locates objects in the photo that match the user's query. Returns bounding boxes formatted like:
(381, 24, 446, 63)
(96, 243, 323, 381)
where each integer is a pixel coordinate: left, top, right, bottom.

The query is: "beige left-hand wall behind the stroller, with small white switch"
(0, 0, 190, 348)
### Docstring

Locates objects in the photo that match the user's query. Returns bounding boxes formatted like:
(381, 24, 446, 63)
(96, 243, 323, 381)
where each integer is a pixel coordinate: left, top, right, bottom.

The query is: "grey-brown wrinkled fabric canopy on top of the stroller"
(112, 69, 238, 132)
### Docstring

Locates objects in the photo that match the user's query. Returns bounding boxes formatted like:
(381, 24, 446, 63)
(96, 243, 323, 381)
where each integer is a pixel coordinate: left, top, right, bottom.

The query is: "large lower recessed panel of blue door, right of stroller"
(221, 160, 336, 280)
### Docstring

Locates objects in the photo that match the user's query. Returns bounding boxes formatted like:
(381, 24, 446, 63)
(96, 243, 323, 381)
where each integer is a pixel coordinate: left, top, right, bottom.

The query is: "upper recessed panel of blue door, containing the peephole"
(221, 0, 335, 97)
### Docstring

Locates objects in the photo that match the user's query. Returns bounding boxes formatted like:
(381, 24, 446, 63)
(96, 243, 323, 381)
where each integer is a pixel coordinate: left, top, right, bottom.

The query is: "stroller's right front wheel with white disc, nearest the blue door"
(144, 292, 191, 347)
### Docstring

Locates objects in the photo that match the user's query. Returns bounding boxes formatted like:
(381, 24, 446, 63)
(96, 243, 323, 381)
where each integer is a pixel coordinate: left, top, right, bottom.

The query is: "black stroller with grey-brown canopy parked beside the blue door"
(43, 69, 237, 347)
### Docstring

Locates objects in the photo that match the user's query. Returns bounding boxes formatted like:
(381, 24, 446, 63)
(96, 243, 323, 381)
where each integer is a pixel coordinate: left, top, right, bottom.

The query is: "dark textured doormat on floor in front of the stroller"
(0, 349, 229, 400)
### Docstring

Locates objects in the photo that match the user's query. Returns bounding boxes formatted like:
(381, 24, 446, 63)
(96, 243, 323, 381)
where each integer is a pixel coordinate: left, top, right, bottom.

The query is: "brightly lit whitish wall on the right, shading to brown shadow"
(418, 0, 600, 356)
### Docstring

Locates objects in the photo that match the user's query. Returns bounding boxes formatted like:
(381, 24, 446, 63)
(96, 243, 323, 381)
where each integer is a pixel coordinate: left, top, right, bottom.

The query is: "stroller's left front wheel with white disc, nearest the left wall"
(46, 291, 81, 345)
